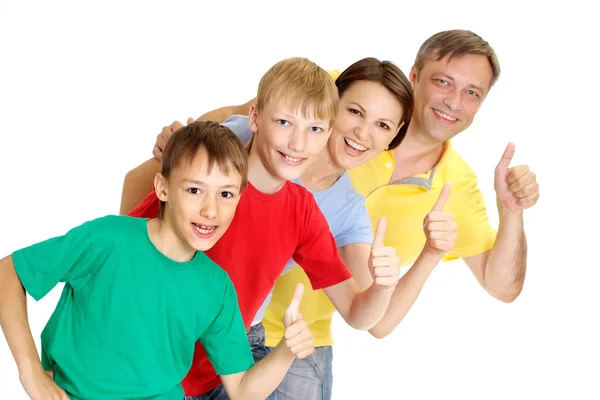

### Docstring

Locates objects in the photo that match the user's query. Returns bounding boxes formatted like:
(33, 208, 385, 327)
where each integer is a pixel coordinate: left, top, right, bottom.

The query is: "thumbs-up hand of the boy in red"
(369, 217, 400, 290)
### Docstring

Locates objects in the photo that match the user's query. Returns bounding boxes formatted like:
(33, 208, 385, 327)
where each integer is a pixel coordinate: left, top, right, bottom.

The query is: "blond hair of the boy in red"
(256, 57, 339, 128)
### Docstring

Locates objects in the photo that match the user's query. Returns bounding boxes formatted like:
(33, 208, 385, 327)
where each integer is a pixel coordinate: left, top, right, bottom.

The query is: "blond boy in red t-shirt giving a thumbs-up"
(123, 58, 400, 399)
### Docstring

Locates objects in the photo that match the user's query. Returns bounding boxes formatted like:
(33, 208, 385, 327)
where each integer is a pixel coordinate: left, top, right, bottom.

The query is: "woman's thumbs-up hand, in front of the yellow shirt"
(423, 182, 458, 256)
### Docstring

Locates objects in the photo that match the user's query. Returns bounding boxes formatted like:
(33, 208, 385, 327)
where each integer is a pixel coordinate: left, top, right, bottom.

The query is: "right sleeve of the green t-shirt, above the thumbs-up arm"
(200, 279, 254, 375)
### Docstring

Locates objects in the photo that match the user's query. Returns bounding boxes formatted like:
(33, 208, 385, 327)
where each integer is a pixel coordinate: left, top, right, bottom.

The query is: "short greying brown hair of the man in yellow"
(414, 29, 500, 88)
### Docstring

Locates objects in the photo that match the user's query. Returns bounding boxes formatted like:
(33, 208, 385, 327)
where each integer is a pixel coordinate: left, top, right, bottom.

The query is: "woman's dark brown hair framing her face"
(335, 57, 414, 150)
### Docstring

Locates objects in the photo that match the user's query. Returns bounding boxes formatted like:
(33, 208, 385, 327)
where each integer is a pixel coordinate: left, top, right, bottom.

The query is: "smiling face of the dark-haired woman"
(328, 80, 403, 169)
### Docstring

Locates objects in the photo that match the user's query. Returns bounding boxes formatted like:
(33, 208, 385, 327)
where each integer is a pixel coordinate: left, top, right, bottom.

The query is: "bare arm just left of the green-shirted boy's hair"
(119, 158, 161, 215)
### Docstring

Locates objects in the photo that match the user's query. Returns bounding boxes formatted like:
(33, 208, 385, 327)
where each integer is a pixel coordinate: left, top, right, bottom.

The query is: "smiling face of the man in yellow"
(410, 54, 493, 142)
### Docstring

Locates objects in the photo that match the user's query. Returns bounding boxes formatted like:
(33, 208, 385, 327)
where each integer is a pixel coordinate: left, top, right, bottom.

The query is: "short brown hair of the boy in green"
(158, 121, 248, 218)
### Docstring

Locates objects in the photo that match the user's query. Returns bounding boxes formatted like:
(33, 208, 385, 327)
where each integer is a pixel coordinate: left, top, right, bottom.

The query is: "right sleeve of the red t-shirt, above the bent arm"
(293, 197, 352, 290)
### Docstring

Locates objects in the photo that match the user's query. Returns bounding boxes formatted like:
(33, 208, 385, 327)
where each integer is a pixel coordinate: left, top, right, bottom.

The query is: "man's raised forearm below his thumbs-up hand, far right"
(484, 213, 527, 302)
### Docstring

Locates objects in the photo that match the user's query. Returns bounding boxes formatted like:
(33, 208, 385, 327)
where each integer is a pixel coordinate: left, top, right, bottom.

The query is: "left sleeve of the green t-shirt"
(12, 223, 90, 300)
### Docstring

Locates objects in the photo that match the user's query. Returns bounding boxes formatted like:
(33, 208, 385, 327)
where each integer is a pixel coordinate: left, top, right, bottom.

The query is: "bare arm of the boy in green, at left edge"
(0, 256, 42, 375)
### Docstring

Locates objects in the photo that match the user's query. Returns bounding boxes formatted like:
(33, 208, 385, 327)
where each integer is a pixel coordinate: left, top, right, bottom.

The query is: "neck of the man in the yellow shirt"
(392, 120, 444, 171)
